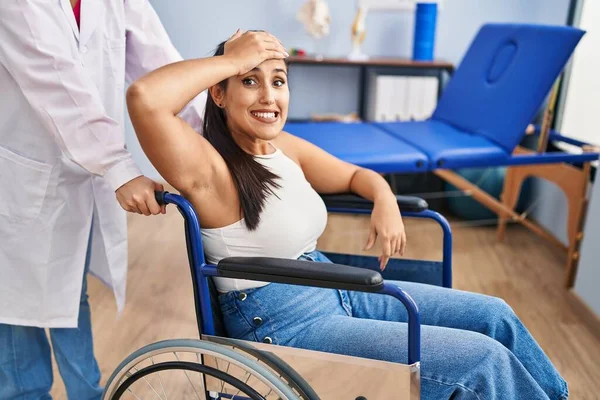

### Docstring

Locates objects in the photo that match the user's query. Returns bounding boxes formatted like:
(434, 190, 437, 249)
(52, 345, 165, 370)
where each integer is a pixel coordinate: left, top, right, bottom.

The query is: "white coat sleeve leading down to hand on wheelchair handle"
(0, 0, 141, 190)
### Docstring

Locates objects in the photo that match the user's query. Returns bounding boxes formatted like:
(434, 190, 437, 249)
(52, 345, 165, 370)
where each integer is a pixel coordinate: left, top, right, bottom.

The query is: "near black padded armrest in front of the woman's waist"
(217, 257, 383, 292)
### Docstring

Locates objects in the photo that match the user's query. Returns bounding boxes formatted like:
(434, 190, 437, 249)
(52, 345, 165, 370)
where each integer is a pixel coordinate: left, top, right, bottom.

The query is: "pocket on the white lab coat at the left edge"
(0, 147, 52, 222)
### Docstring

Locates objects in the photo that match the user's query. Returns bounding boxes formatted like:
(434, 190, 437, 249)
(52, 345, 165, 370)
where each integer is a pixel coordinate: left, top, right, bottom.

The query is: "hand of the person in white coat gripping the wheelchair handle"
(116, 176, 166, 215)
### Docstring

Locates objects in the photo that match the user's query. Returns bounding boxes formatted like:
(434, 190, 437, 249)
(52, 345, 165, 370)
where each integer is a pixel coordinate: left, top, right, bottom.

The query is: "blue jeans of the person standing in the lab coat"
(0, 223, 102, 400)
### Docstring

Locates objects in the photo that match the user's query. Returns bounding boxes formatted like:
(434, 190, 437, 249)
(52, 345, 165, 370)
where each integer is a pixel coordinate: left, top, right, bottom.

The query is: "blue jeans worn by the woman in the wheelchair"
(219, 251, 568, 400)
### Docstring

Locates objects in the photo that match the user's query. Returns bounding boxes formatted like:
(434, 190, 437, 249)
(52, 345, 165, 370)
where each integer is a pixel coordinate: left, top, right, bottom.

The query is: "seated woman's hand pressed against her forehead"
(224, 29, 289, 75)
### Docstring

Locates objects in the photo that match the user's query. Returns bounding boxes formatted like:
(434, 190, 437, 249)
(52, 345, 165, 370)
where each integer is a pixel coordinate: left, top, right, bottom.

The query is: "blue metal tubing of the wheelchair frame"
(157, 192, 452, 365)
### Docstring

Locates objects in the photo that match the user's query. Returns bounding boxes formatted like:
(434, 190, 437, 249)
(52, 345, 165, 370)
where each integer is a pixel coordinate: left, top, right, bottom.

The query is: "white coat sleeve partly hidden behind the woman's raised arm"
(125, 0, 207, 133)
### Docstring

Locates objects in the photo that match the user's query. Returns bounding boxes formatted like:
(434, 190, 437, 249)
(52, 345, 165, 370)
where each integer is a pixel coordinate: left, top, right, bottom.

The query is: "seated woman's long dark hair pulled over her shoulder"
(203, 42, 290, 230)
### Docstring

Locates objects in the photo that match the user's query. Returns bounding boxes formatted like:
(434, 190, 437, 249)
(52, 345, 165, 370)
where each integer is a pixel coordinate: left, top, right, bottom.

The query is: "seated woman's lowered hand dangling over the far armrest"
(365, 197, 406, 271)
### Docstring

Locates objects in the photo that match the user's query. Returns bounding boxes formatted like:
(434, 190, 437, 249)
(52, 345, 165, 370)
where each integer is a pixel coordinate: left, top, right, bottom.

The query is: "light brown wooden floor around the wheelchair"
(52, 206, 600, 399)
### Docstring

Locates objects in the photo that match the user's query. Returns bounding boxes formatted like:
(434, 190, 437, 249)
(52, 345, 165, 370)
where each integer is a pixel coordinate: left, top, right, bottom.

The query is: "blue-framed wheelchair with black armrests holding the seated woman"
(102, 192, 452, 400)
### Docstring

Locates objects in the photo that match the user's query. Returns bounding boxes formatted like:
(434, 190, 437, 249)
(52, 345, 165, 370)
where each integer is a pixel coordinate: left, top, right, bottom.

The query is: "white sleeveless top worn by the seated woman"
(201, 148, 327, 292)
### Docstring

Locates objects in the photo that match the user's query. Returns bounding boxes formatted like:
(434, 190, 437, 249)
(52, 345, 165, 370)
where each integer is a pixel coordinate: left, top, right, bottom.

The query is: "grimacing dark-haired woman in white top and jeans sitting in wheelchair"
(127, 31, 568, 400)
